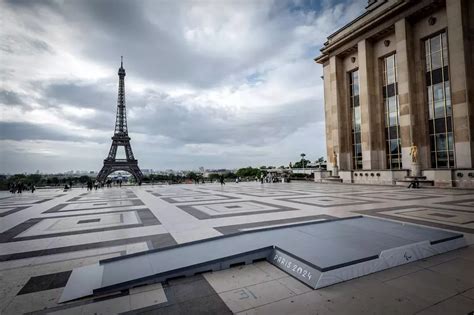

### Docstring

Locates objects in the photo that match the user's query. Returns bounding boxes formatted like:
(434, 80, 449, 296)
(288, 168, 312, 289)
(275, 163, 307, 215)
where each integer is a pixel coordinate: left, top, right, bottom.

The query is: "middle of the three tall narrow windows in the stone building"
(382, 54, 402, 169)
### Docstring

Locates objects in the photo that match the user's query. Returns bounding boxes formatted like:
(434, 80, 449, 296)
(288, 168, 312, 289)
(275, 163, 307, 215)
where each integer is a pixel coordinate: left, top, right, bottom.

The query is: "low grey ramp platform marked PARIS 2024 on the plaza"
(60, 216, 466, 302)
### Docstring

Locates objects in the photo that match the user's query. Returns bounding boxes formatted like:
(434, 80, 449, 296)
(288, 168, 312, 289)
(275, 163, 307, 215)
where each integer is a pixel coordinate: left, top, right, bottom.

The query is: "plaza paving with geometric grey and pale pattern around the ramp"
(0, 182, 474, 314)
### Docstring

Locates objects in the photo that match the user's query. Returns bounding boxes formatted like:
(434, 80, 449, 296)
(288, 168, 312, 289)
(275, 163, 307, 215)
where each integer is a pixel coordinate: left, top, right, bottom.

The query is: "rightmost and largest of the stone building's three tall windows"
(425, 32, 455, 168)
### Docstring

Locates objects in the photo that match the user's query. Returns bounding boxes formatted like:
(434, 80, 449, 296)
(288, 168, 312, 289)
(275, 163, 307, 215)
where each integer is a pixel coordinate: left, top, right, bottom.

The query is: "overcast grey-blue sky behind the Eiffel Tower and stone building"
(0, 0, 367, 173)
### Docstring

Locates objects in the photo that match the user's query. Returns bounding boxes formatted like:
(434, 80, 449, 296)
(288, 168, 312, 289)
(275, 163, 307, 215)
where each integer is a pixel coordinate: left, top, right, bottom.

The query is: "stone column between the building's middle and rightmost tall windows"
(395, 19, 416, 169)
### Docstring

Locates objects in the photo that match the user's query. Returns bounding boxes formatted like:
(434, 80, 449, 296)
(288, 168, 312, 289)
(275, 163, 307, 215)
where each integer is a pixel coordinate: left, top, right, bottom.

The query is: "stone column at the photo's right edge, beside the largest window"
(446, 0, 474, 168)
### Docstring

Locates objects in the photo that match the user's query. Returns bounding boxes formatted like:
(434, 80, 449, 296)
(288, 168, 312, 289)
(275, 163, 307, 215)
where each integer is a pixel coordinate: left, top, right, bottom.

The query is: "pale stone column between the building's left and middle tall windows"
(357, 40, 380, 170)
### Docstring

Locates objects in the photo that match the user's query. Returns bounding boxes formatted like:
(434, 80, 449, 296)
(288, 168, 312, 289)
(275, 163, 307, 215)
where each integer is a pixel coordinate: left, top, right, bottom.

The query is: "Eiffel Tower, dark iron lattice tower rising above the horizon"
(97, 57, 143, 184)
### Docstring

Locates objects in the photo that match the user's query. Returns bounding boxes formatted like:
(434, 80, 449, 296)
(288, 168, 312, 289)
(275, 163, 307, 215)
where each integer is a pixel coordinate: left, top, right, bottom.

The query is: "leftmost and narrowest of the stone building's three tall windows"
(349, 70, 362, 170)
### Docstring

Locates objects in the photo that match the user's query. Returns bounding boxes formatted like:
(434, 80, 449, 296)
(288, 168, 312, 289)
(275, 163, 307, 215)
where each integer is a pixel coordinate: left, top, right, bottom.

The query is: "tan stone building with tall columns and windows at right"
(315, 0, 474, 187)
